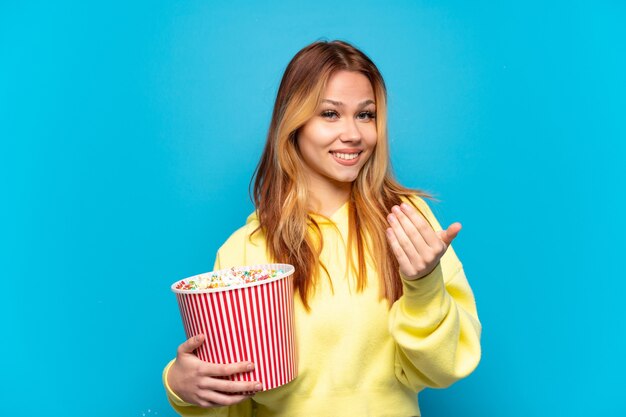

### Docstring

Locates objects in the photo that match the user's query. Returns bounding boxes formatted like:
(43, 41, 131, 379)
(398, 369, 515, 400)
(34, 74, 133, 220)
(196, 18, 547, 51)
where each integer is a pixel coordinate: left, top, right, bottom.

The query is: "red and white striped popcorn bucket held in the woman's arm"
(172, 264, 298, 391)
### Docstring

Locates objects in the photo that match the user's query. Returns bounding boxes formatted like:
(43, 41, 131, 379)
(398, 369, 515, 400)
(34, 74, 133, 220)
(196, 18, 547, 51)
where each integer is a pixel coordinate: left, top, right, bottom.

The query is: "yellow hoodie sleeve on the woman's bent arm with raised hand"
(389, 199, 481, 392)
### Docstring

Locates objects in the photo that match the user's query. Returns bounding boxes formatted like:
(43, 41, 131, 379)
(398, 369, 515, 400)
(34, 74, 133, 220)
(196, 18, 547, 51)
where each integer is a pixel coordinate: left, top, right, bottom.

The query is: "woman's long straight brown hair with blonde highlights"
(253, 41, 426, 309)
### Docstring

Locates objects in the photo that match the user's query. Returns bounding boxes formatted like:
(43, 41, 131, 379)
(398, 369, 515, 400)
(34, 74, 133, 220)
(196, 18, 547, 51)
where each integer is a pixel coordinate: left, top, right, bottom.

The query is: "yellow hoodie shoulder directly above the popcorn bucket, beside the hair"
(215, 213, 268, 269)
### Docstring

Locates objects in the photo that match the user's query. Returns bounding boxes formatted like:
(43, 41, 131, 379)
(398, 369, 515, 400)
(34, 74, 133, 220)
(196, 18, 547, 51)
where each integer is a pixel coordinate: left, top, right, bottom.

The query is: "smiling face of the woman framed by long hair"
(297, 71, 378, 192)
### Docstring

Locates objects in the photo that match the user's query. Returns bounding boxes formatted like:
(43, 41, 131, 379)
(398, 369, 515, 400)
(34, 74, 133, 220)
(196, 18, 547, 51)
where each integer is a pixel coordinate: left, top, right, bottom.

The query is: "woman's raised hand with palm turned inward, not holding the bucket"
(387, 203, 461, 280)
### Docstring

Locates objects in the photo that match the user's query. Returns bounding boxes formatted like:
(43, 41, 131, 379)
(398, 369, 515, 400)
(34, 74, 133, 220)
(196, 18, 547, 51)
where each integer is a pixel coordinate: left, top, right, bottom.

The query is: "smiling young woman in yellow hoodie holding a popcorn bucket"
(164, 41, 481, 417)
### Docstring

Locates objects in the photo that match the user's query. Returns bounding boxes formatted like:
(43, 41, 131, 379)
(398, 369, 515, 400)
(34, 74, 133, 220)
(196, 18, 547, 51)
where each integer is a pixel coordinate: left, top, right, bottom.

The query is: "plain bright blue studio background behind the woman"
(0, 0, 626, 417)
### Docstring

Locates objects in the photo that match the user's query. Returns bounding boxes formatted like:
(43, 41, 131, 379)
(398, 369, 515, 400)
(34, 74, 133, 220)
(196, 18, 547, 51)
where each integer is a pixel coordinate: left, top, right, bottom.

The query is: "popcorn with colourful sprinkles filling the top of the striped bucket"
(174, 268, 284, 291)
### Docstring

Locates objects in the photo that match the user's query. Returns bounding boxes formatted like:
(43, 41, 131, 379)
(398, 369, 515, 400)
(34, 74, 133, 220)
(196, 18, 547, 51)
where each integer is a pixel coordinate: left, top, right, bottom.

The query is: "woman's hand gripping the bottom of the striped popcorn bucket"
(167, 335, 263, 407)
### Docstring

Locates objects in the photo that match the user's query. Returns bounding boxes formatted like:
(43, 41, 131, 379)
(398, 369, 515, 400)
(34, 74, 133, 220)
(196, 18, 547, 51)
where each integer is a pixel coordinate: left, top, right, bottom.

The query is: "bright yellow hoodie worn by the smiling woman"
(163, 199, 481, 417)
